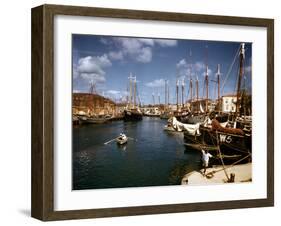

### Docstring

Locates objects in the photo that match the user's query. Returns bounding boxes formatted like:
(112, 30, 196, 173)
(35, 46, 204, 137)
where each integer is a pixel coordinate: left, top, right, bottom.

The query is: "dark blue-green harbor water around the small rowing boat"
(72, 117, 201, 190)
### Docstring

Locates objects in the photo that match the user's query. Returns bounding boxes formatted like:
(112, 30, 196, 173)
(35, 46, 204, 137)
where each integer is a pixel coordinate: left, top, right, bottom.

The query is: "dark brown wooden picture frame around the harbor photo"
(31, 5, 274, 221)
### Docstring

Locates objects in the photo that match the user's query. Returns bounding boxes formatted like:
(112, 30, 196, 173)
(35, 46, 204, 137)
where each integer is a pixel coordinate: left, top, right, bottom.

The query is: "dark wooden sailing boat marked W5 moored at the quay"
(184, 43, 252, 160)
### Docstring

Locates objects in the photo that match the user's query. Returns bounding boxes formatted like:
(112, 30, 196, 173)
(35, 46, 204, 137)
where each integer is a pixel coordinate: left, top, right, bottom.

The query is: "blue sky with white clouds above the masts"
(72, 34, 252, 104)
